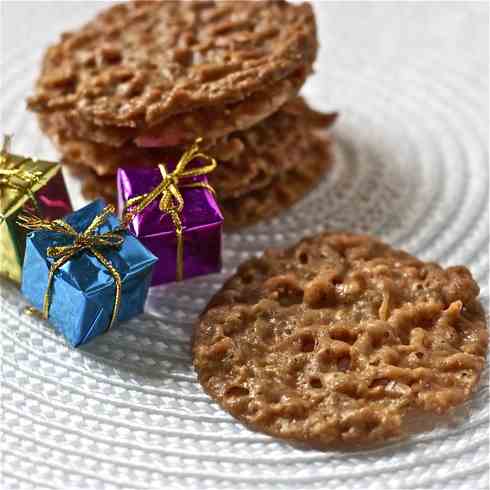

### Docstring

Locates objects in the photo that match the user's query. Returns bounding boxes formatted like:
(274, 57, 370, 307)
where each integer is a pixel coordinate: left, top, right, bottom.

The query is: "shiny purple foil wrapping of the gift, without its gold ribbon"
(117, 167, 223, 286)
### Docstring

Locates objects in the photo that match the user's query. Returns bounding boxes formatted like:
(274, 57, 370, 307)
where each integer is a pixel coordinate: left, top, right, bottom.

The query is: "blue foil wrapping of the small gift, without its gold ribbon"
(21, 200, 157, 347)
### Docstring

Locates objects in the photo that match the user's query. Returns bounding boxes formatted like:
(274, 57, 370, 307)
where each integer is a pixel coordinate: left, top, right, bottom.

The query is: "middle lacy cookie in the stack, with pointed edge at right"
(48, 98, 336, 199)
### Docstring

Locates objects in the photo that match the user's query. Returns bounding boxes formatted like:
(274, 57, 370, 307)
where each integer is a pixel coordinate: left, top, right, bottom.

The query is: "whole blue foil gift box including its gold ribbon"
(19, 200, 157, 346)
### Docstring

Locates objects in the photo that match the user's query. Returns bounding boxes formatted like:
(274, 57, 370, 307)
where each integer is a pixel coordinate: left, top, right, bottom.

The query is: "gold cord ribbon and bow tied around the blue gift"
(18, 205, 124, 330)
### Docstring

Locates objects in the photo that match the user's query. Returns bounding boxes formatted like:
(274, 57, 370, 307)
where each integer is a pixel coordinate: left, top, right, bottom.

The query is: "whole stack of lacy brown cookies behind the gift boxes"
(29, 1, 335, 227)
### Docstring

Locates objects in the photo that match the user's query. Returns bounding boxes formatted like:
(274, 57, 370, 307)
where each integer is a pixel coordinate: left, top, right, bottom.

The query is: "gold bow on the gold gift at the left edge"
(0, 135, 42, 211)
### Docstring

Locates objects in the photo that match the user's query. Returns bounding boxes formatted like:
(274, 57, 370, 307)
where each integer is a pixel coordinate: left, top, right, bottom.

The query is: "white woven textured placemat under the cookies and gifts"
(0, 2, 489, 490)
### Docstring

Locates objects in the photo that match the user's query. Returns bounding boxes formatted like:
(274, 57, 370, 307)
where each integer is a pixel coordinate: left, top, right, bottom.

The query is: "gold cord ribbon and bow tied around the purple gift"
(123, 138, 217, 281)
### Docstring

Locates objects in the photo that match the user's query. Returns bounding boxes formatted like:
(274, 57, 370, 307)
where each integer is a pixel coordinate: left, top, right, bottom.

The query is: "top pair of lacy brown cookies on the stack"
(29, 1, 317, 146)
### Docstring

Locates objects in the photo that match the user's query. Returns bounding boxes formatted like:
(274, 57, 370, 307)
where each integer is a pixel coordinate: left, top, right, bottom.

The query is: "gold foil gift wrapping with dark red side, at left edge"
(0, 154, 72, 283)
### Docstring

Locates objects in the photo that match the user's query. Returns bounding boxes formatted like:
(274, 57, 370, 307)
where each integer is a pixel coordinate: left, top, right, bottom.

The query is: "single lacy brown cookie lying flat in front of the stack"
(193, 233, 488, 446)
